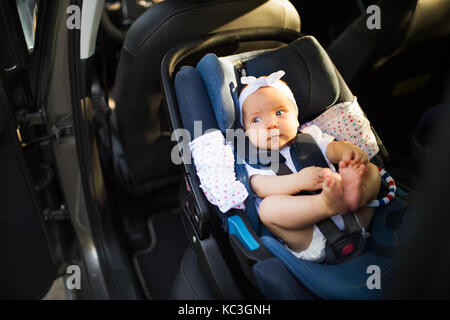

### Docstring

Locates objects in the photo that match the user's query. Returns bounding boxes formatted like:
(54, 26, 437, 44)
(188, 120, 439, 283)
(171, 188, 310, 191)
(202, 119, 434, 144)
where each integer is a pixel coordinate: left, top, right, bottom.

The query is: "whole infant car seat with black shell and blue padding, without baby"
(161, 29, 414, 299)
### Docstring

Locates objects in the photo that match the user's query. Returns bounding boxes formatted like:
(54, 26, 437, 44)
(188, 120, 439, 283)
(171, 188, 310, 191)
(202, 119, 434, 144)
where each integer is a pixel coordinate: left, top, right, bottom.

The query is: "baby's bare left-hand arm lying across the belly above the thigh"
(250, 167, 324, 199)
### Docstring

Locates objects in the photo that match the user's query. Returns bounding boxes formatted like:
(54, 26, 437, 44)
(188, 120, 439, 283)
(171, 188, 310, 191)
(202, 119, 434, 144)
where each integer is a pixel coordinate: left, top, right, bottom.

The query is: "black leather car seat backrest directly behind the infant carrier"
(112, 0, 300, 194)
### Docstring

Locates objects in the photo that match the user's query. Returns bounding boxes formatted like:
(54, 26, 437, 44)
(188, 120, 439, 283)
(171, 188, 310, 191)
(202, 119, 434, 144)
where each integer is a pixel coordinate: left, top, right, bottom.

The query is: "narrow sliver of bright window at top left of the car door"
(16, 0, 39, 53)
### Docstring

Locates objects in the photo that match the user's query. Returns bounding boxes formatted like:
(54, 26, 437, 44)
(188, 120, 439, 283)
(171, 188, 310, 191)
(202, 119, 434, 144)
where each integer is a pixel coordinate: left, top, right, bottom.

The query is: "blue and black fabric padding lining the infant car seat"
(175, 37, 410, 299)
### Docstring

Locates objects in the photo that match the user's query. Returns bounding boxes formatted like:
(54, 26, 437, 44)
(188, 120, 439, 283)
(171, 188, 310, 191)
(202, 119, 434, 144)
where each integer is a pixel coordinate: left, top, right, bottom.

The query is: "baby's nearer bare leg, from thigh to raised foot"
(259, 171, 347, 252)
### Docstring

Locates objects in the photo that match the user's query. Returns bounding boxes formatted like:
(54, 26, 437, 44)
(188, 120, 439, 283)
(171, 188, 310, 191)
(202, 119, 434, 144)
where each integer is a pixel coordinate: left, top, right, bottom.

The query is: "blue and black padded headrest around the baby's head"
(197, 36, 344, 132)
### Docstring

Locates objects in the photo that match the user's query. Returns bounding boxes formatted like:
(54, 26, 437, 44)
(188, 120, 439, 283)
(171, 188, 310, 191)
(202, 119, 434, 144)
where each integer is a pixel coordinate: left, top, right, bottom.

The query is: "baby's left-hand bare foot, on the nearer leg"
(322, 169, 348, 214)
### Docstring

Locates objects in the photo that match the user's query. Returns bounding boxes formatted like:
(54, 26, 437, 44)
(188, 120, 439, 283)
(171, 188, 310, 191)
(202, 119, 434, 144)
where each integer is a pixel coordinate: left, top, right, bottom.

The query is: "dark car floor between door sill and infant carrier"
(110, 182, 188, 300)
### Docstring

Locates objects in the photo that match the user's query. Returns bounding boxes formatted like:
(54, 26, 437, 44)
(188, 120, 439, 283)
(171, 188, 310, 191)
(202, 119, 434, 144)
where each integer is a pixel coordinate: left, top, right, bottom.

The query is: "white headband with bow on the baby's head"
(239, 70, 298, 126)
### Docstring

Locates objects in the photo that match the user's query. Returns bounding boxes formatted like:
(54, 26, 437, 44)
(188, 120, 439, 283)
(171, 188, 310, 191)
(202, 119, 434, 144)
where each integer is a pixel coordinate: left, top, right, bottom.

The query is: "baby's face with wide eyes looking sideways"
(242, 87, 299, 150)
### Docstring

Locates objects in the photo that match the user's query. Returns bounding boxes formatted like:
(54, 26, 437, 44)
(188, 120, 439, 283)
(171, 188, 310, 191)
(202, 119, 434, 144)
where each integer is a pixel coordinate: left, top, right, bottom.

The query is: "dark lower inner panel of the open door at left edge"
(0, 79, 55, 299)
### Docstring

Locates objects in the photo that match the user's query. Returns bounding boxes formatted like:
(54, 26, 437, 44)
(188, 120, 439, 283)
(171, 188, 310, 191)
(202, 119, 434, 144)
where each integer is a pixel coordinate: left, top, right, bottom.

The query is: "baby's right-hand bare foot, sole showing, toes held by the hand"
(339, 161, 366, 211)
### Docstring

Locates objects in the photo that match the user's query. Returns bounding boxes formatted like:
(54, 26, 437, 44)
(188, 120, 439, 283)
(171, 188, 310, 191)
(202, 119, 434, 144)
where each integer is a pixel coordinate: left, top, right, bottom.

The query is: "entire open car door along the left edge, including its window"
(0, 0, 61, 299)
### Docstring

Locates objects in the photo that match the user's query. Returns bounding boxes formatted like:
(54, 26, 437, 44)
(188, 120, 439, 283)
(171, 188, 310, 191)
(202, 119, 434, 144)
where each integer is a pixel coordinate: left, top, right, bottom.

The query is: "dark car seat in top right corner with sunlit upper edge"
(327, 0, 450, 83)
